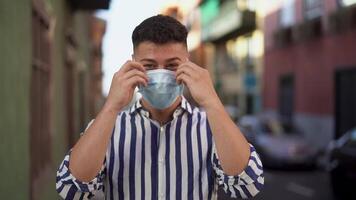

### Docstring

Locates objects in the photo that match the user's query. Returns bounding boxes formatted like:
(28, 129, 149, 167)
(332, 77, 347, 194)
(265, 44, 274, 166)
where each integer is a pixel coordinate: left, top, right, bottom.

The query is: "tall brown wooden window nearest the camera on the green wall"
(30, 0, 51, 199)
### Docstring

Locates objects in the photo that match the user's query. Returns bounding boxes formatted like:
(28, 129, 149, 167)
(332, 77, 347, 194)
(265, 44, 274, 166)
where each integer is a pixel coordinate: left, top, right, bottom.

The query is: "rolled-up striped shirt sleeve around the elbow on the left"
(56, 119, 106, 200)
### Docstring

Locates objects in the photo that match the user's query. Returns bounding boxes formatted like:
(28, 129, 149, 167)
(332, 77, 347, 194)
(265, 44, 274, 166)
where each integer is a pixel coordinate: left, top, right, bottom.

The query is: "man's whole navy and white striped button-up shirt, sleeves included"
(56, 97, 264, 200)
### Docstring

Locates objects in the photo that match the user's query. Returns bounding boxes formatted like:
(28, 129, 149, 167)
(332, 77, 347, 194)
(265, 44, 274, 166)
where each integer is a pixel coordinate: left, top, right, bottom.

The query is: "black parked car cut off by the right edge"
(328, 127, 356, 200)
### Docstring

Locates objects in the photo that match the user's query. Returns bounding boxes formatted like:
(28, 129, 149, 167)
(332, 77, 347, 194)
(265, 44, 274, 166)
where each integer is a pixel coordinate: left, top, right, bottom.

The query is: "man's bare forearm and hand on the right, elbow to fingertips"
(176, 61, 250, 175)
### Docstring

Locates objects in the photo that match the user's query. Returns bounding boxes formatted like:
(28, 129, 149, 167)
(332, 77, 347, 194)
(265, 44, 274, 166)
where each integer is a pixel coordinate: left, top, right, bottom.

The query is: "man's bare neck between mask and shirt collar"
(141, 97, 182, 125)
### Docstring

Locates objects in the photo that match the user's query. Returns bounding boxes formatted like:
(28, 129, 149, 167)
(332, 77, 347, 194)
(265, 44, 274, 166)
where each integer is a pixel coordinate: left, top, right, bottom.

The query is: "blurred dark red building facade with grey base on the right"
(263, 0, 356, 148)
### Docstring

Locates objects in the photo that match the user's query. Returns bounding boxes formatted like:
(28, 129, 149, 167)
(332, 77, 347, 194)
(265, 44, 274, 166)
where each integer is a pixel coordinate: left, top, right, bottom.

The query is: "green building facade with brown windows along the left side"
(0, 0, 109, 199)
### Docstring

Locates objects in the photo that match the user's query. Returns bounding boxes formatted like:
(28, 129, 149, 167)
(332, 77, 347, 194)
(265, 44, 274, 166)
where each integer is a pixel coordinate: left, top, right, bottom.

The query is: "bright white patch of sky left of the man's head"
(97, 0, 177, 96)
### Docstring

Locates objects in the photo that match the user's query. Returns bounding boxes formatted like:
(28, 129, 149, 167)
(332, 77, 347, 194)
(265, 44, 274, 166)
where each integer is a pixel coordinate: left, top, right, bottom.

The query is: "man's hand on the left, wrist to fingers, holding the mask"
(106, 61, 148, 112)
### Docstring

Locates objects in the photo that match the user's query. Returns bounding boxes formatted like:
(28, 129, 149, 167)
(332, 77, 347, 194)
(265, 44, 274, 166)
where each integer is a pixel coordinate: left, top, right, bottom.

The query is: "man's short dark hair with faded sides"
(132, 15, 188, 49)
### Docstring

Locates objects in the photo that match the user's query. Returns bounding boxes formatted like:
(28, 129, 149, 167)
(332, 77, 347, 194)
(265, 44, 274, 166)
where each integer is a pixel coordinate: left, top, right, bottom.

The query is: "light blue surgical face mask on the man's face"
(139, 69, 183, 110)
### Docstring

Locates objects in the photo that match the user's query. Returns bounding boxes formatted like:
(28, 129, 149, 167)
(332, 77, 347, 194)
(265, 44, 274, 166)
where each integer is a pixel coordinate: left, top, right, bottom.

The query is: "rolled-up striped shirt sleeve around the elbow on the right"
(212, 144, 264, 199)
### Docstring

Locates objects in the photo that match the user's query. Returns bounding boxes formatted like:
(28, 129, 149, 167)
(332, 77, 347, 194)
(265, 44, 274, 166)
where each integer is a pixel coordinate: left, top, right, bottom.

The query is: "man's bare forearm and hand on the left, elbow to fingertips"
(69, 61, 148, 182)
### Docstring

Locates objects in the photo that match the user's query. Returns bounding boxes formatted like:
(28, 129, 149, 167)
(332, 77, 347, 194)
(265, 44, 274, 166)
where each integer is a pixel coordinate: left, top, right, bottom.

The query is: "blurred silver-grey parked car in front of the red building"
(238, 116, 318, 169)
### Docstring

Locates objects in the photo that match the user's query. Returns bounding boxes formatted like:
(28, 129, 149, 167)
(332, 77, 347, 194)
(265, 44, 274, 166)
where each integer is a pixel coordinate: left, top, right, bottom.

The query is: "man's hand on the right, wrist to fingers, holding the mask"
(176, 61, 220, 108)
